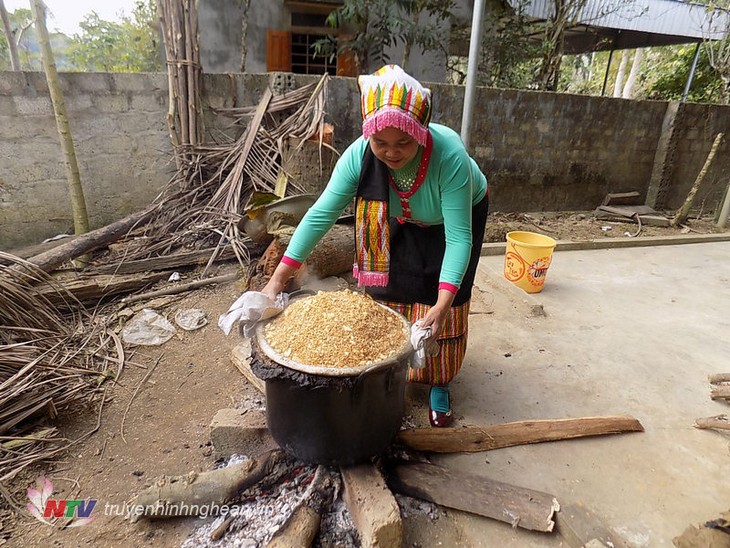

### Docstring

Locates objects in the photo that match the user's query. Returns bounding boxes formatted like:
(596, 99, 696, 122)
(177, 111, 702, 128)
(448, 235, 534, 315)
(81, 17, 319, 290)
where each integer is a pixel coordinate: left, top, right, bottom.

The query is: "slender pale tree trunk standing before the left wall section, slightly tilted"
(30, 0, 89, 235)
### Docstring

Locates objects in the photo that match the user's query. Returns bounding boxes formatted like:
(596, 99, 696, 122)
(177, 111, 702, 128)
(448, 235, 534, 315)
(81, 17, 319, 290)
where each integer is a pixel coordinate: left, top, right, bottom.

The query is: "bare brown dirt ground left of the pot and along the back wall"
(0, 213, 715, 547)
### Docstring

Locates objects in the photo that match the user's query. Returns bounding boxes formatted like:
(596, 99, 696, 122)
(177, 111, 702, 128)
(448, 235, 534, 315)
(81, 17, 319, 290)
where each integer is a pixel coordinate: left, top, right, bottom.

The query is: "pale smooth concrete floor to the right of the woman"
(436, 242, 730, 547)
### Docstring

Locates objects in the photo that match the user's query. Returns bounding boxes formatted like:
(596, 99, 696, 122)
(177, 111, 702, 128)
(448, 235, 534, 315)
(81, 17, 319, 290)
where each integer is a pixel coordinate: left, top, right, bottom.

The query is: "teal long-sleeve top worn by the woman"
(284, 123, 487, 288)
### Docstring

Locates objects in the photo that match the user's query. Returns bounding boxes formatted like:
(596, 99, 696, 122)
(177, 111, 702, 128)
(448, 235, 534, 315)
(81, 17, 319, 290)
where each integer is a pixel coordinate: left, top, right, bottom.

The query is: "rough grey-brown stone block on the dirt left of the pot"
(210, 409, 277, 458)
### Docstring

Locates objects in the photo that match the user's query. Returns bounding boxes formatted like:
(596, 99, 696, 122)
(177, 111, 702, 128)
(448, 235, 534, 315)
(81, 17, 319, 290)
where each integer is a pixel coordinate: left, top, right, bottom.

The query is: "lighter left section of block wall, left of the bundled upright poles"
(0, 72, 174, 249)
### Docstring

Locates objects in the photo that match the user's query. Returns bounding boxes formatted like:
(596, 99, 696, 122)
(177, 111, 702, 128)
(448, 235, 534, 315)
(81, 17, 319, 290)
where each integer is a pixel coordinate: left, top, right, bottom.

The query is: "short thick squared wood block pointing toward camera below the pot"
(340, 464, 403, 548)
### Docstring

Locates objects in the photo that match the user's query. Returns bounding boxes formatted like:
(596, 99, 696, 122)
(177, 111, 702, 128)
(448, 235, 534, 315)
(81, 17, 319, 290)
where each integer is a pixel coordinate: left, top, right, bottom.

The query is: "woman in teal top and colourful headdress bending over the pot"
(263, 65, 488, 427)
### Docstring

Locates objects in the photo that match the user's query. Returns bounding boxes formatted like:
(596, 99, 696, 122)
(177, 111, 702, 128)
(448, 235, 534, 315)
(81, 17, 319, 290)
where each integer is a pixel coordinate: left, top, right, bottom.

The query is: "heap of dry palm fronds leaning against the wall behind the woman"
(98, 75, 327, 274)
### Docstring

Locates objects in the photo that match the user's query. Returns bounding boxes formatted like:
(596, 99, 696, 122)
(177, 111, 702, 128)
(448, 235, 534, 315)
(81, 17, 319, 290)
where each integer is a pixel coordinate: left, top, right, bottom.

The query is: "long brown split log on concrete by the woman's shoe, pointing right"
(398, 416, 644, 453)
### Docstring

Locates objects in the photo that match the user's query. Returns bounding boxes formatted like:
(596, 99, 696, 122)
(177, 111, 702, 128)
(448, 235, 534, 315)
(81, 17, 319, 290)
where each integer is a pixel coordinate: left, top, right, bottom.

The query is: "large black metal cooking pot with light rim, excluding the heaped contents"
(251, 309, 413, 465)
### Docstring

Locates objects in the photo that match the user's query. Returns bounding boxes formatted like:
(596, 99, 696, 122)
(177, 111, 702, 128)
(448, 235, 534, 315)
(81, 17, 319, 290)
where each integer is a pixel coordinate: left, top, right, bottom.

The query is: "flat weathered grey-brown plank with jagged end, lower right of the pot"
(389, 463, 560, 532)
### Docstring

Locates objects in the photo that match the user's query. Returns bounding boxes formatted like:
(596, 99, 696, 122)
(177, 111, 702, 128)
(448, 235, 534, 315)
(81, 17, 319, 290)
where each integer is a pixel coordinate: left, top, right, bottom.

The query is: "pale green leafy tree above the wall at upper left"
(68, 0, 162, 72)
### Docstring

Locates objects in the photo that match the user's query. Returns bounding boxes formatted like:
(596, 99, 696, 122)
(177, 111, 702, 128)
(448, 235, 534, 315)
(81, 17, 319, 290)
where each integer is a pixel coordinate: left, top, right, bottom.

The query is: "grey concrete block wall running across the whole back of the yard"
(0, 72, 730, 249)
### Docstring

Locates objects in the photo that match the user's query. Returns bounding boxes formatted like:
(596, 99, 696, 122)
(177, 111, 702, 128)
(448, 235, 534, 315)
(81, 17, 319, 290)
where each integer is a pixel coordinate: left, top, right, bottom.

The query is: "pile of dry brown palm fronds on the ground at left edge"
(0, 252, 124, 482)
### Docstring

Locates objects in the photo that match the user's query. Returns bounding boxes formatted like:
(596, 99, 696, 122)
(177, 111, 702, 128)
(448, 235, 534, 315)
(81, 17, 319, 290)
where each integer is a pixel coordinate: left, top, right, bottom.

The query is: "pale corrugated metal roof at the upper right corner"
(509, 0, 730, 49)
